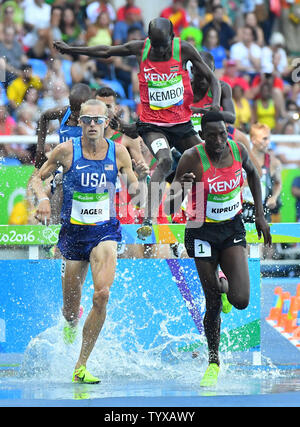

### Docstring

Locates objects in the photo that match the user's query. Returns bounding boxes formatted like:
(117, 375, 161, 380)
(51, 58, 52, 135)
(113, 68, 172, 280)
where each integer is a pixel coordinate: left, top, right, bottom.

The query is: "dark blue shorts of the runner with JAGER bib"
(57, 220, 122, 261)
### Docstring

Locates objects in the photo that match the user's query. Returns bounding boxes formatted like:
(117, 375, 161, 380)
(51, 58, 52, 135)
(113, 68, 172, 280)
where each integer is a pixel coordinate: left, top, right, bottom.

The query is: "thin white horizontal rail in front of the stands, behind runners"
(0, 134, 300, 144)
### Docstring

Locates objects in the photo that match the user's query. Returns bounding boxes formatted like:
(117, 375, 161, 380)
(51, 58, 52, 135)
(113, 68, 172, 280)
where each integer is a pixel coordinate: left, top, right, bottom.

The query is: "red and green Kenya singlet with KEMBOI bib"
(138, 37, 193, 126)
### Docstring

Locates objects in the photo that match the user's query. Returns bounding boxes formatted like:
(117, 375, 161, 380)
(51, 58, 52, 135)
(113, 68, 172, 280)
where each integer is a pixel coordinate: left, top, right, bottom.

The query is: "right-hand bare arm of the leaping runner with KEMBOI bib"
(182, 41, 221, 111)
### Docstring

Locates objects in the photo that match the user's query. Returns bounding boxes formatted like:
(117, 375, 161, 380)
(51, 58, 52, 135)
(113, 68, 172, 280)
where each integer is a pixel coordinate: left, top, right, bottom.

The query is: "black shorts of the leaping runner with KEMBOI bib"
(136, 120, 197, 154)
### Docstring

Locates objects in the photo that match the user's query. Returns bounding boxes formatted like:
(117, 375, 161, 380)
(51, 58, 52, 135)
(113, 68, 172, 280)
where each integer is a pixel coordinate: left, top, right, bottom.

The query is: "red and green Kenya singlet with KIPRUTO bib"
(190, 139, 244, 222)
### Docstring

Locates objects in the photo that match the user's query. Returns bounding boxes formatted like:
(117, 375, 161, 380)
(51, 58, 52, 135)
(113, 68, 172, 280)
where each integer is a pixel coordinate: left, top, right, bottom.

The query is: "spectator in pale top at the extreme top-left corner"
(0, 0, 24, 41)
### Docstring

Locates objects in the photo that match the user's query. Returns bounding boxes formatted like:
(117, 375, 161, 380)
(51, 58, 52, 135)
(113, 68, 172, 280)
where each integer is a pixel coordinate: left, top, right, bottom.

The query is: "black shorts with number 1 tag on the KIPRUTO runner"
(184, 215, 247, 262)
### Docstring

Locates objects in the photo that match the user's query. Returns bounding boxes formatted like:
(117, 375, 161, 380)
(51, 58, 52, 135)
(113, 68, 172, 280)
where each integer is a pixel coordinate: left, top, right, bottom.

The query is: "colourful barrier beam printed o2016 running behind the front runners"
(0, 223, 300, 246)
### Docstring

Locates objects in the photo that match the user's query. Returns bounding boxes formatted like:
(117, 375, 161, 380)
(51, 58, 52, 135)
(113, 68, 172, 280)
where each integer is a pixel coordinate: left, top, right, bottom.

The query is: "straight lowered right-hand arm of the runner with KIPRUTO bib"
(238, 144, 272, 246)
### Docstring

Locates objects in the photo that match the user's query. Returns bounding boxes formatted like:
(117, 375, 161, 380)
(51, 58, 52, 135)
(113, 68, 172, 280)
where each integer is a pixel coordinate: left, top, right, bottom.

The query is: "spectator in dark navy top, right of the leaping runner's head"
(202, 5, 236, 51)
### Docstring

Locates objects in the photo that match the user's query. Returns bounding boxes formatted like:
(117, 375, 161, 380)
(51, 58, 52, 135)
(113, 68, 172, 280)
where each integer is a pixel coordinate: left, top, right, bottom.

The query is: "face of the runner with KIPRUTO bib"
(201, 121, 228, 156)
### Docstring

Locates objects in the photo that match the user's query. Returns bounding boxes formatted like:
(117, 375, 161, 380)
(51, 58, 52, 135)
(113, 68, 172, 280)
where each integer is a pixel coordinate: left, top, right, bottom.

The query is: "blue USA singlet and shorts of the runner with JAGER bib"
(58, 138, 121, 260)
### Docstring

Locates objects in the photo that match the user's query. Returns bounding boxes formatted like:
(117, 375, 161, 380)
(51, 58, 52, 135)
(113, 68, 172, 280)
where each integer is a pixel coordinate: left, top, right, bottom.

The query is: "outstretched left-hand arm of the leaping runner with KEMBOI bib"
(53, 40, 144, 58)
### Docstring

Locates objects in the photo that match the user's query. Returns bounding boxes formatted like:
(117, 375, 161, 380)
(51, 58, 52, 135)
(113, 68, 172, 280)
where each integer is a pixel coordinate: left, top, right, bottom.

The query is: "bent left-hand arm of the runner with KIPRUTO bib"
(164, 147, 202, 215)
